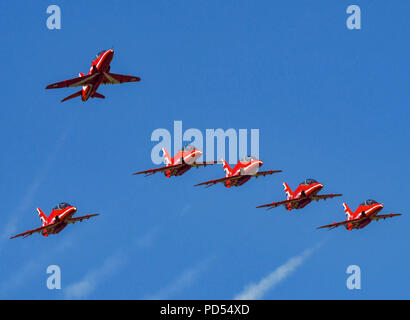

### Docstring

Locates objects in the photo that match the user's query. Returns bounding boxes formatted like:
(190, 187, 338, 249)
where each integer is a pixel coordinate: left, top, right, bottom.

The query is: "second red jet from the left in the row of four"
(195, 157, 282, 188)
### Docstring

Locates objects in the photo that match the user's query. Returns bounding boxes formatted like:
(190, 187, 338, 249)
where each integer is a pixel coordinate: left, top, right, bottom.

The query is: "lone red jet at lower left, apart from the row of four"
(10, 202, 98, 239)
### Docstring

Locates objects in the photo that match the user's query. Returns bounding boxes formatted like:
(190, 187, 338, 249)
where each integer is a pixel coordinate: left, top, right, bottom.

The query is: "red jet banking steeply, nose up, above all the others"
(46, 49, 141, 102)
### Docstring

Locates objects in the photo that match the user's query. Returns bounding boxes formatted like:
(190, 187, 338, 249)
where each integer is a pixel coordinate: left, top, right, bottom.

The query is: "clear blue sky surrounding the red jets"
(0, 0, 410, 299)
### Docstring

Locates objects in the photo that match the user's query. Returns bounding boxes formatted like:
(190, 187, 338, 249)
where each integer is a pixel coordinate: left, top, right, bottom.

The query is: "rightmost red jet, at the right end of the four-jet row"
(317, 200, 401, 231)
